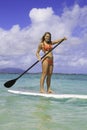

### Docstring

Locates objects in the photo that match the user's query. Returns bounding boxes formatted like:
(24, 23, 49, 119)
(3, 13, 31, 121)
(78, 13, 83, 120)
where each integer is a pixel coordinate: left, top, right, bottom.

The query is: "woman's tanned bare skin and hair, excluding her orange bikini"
(36, 32, 67, 93)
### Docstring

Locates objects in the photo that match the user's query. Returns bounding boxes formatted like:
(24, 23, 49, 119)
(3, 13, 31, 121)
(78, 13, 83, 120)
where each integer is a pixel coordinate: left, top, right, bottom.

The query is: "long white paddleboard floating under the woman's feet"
(8, 90, 87, 99)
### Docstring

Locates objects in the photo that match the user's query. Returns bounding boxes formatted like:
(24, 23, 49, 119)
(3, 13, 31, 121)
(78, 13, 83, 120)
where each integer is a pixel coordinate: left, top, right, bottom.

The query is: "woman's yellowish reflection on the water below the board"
(33, 98, 53, 130)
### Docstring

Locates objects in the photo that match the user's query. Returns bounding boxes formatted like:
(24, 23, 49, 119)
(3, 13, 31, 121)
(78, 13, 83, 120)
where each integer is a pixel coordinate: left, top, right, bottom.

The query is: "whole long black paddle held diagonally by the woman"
(4, 39, 64, 88)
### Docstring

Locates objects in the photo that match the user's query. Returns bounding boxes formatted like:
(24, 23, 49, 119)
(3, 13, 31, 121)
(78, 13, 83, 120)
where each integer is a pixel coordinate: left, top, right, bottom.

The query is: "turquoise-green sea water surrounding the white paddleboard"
(0, 74, 87, 130)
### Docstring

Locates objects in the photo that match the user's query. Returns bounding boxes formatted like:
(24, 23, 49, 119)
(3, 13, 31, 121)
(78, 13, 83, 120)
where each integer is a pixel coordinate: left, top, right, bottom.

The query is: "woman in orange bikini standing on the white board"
(36, 32, 66, 93)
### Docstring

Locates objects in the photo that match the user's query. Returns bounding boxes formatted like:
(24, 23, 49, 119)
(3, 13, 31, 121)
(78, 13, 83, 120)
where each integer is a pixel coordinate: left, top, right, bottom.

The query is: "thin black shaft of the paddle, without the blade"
(17, 39, 64, 79)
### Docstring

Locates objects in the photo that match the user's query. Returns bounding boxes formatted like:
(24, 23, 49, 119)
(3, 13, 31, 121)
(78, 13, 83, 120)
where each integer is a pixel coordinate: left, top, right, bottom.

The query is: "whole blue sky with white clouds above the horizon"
(0, 0, 87, 74)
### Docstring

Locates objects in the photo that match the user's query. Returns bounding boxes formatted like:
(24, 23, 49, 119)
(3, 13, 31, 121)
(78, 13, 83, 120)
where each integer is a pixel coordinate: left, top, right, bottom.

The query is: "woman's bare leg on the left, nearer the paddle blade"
(40, 59, 48, 93)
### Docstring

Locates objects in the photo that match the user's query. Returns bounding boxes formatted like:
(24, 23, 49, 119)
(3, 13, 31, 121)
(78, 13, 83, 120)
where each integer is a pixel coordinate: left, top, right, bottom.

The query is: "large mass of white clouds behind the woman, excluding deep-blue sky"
(0, 4, 87, 73)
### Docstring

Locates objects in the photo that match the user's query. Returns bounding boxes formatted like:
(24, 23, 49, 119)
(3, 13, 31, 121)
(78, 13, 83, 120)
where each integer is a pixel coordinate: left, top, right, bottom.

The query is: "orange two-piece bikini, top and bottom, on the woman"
(42, 43, 53, 66)
